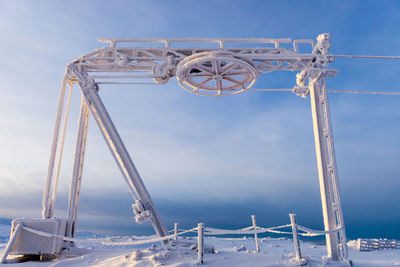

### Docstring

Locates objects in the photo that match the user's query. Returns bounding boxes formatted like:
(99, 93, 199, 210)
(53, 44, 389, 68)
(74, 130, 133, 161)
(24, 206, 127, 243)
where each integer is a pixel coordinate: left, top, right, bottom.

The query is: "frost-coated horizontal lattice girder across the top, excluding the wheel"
(67, 38, 333, 95)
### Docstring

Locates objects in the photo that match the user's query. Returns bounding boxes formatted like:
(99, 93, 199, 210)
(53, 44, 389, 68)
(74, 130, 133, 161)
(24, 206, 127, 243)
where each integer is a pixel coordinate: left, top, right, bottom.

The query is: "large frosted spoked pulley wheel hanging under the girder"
(176, 51, 257, 96)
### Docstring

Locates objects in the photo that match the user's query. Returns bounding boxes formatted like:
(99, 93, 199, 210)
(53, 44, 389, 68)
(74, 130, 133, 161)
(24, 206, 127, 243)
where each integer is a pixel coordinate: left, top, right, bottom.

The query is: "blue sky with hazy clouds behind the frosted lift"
(0, 0, 400, 241)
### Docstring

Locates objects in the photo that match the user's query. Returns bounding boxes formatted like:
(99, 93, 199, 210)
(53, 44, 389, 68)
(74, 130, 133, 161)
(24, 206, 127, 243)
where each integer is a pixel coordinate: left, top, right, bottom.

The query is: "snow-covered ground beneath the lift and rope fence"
(0, 223, 400, 267)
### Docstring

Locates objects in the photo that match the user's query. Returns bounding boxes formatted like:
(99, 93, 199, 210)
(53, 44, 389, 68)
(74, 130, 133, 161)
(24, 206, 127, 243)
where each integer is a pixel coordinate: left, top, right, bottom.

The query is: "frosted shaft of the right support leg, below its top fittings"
(309, 75, 348, 261)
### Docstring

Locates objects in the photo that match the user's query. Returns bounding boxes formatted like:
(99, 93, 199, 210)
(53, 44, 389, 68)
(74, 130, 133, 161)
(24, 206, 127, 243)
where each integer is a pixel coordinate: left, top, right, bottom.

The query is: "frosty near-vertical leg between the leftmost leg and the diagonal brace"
(67, 96, 89, 240)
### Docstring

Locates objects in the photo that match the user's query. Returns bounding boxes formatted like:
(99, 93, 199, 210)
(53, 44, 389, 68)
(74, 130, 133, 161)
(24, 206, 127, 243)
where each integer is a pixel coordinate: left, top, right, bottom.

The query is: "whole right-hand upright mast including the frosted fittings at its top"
(297, 34, 350, 263)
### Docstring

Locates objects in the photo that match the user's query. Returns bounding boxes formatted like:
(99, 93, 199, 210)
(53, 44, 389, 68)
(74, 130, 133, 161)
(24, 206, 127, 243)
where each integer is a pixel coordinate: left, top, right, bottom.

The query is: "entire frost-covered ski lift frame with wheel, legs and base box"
(0, 34, 351, 264)
